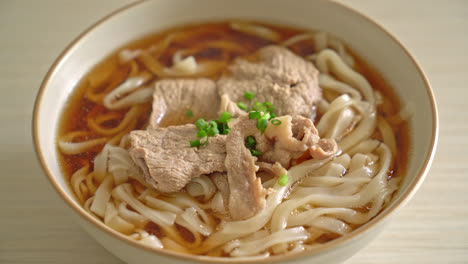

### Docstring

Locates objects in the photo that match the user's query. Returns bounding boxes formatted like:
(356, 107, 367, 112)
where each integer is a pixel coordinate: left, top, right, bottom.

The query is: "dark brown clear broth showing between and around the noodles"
(58, 22, 409, 252)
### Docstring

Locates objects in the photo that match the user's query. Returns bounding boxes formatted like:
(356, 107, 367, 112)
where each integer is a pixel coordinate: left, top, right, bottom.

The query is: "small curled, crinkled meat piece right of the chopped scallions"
(264, 115, 337, 168)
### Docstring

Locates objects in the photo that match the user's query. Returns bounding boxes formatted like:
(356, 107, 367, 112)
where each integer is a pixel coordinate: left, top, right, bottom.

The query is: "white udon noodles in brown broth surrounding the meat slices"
(57, 22, 408, 258)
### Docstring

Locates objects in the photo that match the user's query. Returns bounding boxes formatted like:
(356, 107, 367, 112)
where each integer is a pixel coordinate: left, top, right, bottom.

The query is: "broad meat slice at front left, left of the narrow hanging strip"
(129, 124, 226, 192)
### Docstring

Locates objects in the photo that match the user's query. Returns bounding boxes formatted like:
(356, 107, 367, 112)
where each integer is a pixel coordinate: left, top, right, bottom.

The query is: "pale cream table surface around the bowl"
(0, 0, 468, 264)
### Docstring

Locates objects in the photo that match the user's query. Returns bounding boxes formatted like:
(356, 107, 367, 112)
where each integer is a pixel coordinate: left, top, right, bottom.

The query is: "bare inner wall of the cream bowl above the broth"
(33, 0, 437, 260)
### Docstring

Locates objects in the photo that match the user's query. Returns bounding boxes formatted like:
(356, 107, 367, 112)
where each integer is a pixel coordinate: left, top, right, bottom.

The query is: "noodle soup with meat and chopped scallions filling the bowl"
(57, 21, 408, 258)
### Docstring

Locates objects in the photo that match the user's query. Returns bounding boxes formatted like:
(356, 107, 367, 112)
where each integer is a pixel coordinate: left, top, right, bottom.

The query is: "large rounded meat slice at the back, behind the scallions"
(217, 46, 321, 117)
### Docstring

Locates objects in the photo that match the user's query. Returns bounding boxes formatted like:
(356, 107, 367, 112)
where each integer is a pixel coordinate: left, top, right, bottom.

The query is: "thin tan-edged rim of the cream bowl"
(32, 0, 439, 263)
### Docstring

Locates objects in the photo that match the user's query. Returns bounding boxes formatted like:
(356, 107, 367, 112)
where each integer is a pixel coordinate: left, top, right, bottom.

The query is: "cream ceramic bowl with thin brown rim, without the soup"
(33, 0, 438, 264)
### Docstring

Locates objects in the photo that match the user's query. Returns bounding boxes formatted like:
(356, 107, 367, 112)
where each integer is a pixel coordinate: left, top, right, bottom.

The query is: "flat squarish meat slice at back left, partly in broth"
(149, 78, 220, 128)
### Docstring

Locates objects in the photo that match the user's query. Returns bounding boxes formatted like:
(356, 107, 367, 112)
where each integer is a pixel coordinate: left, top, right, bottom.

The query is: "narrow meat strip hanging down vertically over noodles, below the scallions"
(224, 116, 265, 220)
